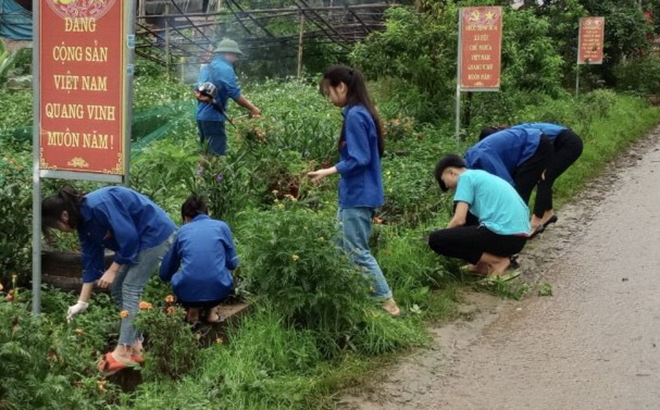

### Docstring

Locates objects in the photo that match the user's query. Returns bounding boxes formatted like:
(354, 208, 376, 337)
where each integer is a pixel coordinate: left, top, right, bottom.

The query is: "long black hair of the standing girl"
(319, 65, 385, 157)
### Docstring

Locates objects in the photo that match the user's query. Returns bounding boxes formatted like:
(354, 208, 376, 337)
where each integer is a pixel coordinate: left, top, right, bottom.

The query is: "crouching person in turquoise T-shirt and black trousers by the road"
(429, 154, 530, 279)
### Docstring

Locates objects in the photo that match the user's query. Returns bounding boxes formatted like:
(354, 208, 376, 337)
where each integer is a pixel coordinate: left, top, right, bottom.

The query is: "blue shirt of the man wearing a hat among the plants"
(197, 54, 241, 121)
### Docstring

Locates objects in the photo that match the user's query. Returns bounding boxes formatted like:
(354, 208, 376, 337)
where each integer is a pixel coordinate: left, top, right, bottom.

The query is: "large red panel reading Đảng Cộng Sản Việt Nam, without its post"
(38, 0, 126, 175)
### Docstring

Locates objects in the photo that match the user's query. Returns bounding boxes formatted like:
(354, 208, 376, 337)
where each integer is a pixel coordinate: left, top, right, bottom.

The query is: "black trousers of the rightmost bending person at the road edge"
(534, 130, 583, 218)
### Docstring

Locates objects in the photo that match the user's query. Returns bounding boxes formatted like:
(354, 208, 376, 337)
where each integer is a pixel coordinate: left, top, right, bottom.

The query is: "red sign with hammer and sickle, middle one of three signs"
(458, 7, 503, 91)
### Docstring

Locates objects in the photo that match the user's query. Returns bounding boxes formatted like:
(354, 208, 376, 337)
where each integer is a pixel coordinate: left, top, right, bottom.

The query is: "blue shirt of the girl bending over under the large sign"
(78, 186, 175, 283)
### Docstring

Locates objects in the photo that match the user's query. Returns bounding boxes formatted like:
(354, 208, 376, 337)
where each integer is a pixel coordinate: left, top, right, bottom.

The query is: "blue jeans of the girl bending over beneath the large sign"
(110, 233, 176, 345)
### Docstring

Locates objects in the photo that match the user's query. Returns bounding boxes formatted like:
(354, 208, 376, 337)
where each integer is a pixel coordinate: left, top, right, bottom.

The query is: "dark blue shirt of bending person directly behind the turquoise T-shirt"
(465, 128, 541, 186)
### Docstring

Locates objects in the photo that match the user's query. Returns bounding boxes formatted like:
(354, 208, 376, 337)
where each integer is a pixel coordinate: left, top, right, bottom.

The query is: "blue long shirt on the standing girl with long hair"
(335, 105, 384, 209)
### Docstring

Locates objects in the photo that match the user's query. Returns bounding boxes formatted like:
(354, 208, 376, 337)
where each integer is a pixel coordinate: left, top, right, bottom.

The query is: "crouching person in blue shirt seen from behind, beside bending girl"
(160, 195, 239, 323)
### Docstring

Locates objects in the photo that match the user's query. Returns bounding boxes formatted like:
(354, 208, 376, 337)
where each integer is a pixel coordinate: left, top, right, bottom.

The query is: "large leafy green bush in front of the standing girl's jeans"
(241, 200, 369, 350)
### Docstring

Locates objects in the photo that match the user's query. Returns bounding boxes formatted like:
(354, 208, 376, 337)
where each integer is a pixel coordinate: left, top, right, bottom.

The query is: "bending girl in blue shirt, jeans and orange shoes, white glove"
(41, 186, 175, 375)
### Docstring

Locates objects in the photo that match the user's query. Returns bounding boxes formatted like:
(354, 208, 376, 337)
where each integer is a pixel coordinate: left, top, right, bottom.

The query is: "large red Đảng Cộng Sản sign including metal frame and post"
(32, 0, 136, 314)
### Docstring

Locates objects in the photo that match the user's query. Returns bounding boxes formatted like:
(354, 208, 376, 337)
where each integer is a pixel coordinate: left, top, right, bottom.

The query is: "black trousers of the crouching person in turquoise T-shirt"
(429, 225, 527, 264)
